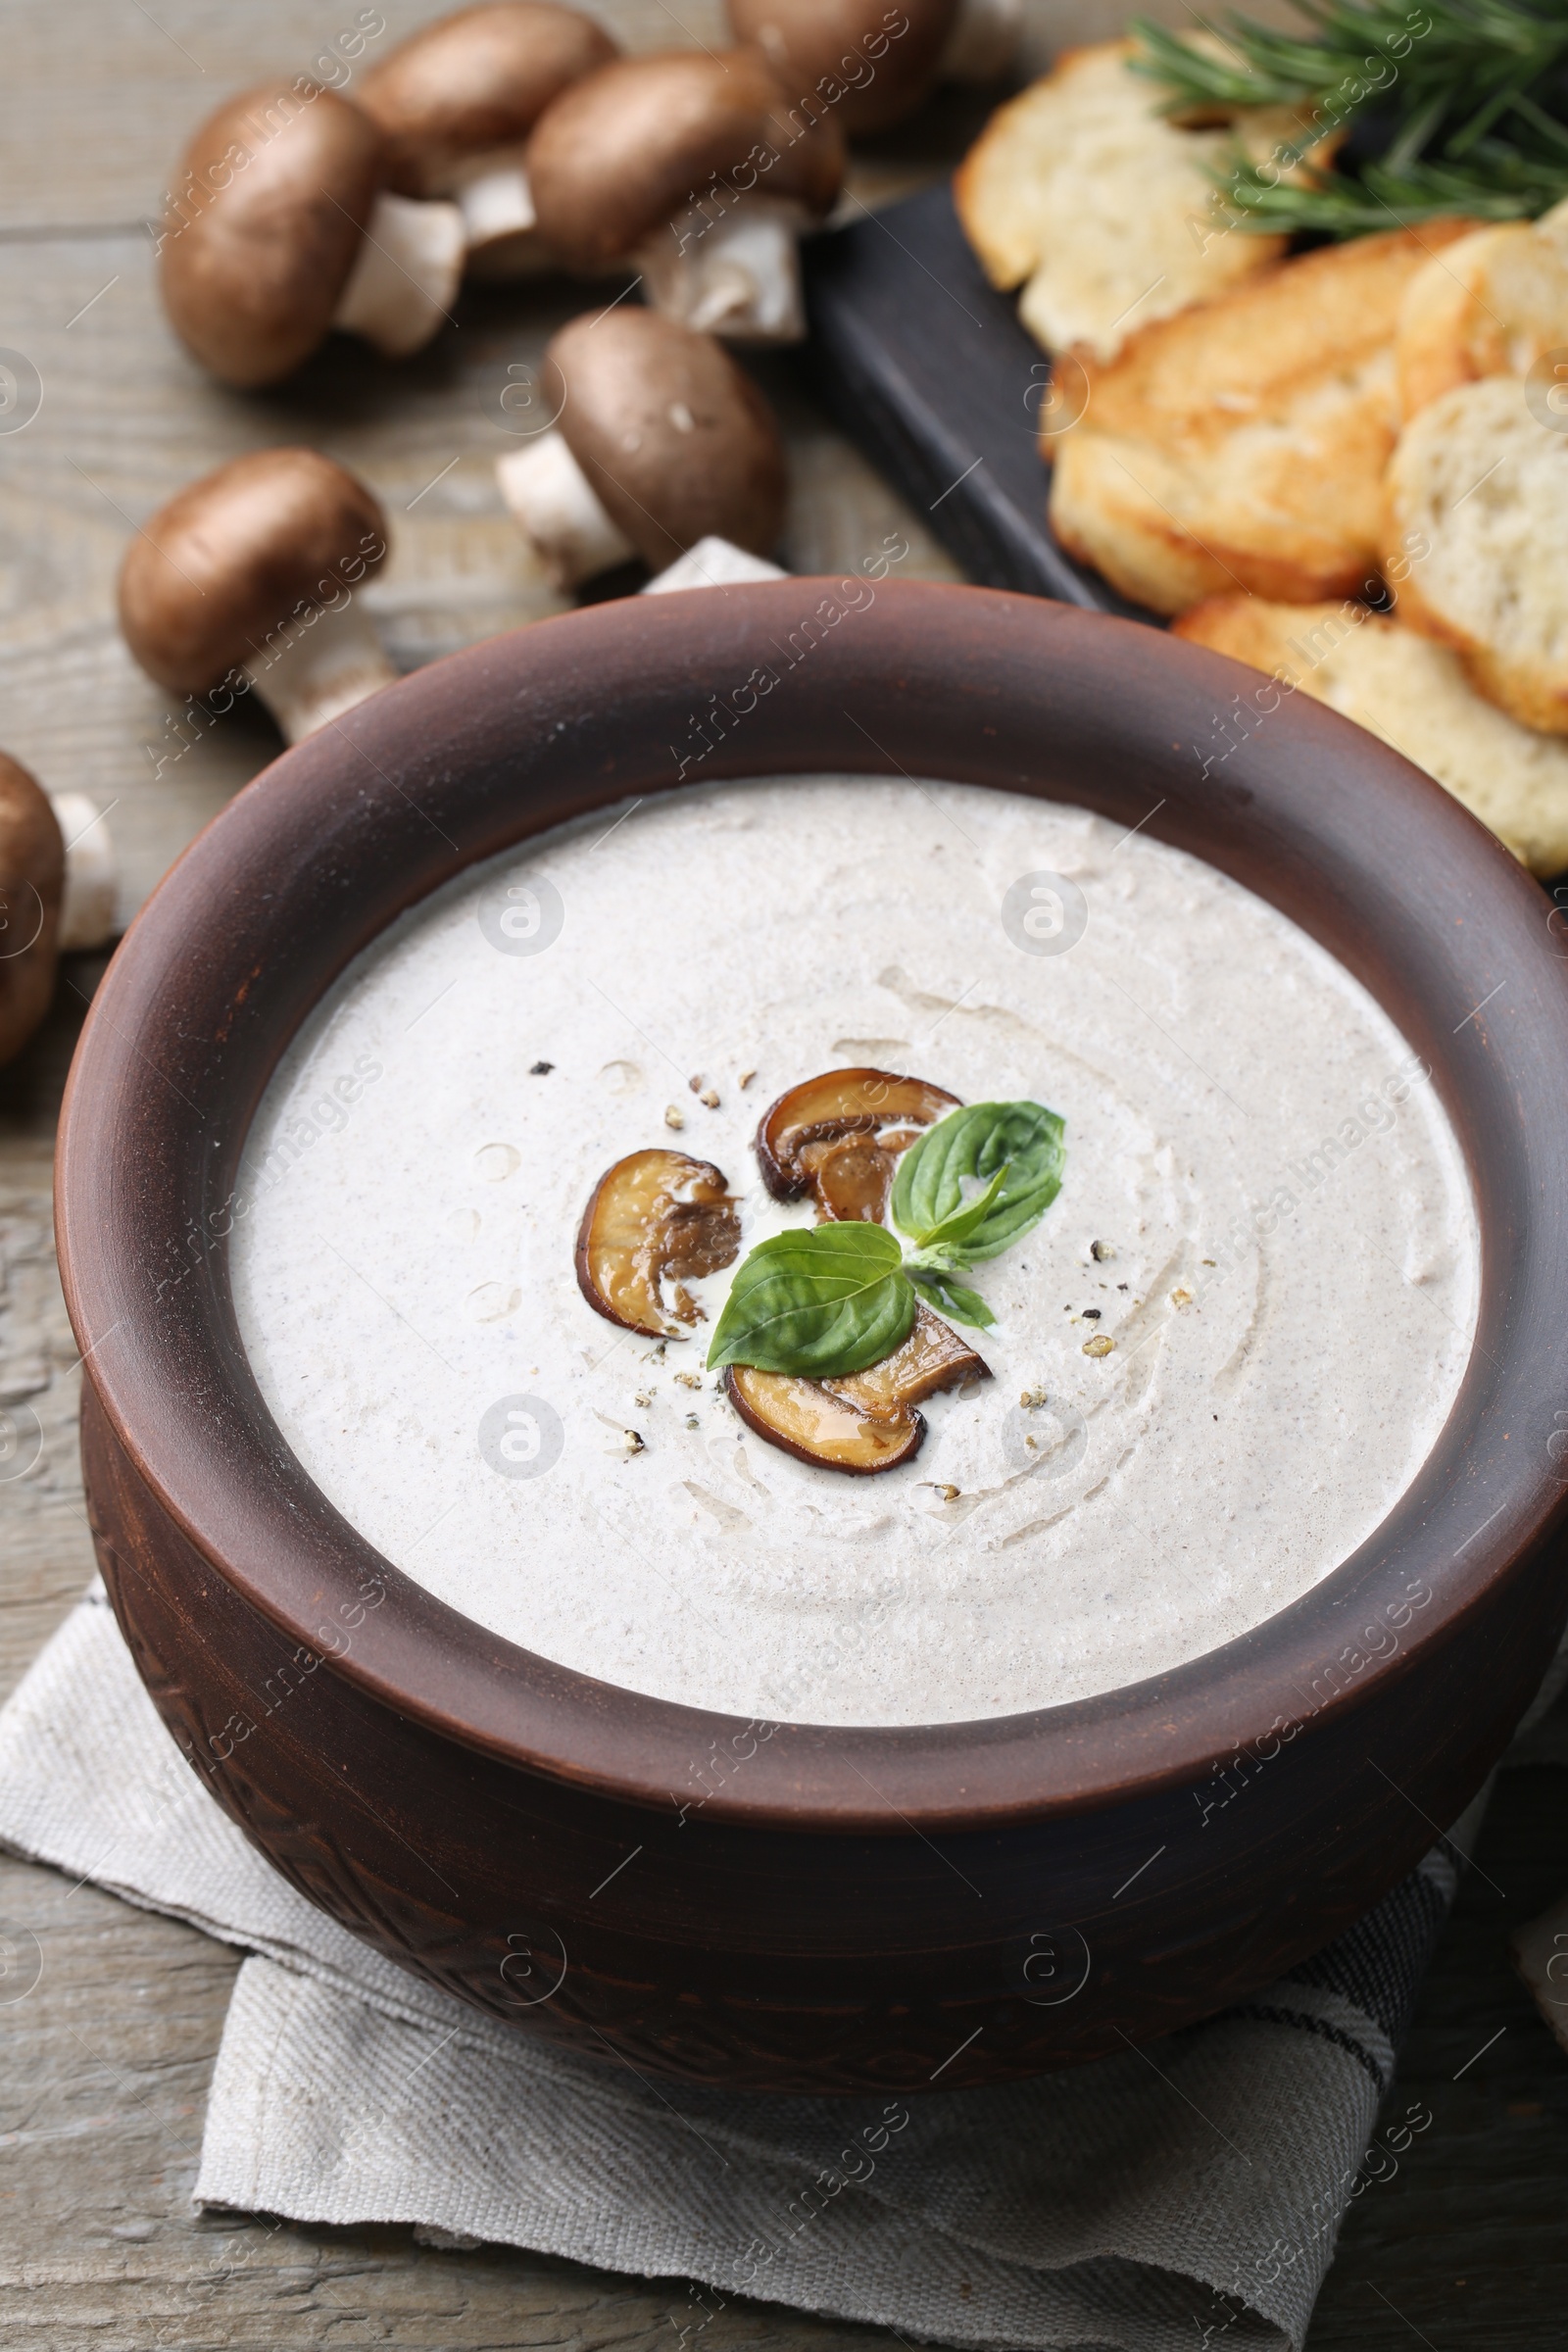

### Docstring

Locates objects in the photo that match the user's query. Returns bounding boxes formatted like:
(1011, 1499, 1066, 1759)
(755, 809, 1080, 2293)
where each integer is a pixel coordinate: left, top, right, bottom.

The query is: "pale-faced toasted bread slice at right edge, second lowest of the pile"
(1385, 376, 1568, 734)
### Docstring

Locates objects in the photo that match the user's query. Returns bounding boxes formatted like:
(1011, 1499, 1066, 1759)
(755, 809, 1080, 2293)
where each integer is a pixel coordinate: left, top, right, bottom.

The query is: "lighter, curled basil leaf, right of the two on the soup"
(891, 1103, 1067, 1263)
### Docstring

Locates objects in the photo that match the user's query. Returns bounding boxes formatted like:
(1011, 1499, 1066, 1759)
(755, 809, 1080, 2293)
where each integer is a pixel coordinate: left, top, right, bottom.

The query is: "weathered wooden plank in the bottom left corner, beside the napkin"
(0, 1863, 894, 2352)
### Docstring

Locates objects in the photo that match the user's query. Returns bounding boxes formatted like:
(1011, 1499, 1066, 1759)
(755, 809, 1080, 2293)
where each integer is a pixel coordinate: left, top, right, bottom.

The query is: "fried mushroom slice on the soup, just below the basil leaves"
(724, 1305, 990, 1477)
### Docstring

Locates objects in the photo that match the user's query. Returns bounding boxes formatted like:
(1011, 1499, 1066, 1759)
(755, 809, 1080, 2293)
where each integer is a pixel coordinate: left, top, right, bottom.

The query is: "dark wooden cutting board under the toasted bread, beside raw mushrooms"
(804, 181, 1152, 621)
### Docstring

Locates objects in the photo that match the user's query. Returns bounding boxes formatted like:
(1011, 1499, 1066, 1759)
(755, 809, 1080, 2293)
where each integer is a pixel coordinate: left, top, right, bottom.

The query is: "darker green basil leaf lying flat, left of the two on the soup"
(708, 1223, 914, 1381)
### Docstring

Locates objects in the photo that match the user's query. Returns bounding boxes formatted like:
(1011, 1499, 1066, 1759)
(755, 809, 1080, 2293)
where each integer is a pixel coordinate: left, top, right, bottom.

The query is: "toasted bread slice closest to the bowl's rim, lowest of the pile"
(1173, 595, 1568, 875)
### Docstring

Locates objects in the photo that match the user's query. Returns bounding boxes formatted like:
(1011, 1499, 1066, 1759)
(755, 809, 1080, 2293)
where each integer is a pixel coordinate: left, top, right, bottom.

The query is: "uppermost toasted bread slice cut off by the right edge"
(1398, 205, 1568, 423)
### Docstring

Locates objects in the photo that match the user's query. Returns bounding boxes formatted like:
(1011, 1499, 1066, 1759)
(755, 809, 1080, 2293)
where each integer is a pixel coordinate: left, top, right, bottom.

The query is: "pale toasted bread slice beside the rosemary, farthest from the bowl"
(955, 40, 1302, 360)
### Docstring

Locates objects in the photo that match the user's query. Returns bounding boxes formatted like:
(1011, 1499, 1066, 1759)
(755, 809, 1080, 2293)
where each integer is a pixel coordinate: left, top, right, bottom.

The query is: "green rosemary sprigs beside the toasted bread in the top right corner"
(1133, 0, 1568, 237)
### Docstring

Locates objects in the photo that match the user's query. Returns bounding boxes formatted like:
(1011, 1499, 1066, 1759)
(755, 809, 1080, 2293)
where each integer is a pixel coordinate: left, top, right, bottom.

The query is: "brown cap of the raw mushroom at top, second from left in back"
(360, 0, 620, 195)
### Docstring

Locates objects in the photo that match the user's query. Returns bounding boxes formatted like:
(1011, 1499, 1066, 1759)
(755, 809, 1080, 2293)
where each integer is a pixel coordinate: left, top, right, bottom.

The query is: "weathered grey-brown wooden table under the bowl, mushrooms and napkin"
(0, 0, 1568, 2352)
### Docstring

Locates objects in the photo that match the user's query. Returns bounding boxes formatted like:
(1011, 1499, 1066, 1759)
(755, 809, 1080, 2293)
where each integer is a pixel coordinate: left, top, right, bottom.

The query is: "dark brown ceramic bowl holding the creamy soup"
(59, 578, 1568, 2091)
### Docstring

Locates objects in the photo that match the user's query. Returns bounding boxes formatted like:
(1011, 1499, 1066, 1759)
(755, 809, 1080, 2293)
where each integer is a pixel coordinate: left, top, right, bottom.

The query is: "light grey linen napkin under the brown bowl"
(0, 1586, 1474, 2352)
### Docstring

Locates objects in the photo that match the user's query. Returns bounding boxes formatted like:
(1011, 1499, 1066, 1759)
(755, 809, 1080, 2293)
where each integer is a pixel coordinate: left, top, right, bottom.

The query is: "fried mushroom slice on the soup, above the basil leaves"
(757, 1070, 959, 1225)
